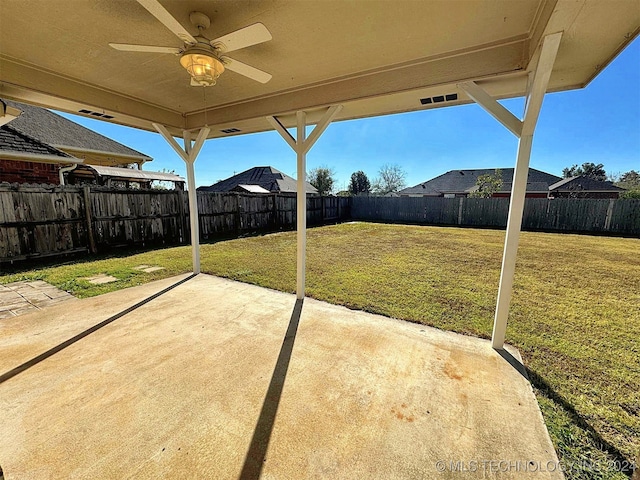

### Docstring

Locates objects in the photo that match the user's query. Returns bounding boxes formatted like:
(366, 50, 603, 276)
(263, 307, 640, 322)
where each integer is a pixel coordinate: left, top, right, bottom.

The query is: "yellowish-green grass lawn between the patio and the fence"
(0, 223, 640, 479)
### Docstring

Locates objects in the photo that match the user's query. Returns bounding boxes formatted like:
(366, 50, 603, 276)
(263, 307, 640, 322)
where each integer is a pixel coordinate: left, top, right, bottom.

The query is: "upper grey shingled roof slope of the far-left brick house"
(5, 100, 152, 161)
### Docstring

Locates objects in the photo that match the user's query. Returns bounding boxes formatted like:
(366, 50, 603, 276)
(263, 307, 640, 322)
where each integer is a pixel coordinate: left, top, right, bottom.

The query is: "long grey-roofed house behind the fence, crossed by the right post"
(398, 168, 561, 198)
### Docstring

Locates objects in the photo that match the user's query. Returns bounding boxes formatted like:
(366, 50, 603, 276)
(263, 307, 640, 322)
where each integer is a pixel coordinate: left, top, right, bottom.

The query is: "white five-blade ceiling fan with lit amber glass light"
(109, 0, 272, 87)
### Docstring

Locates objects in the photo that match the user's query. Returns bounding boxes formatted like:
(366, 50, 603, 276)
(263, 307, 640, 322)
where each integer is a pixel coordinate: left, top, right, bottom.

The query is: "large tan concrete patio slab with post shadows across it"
(0, 275, 562, 480)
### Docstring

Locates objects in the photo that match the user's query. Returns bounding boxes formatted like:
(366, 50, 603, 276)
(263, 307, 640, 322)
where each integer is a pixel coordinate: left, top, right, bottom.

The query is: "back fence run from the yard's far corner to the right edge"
(351, 197, 640, 236)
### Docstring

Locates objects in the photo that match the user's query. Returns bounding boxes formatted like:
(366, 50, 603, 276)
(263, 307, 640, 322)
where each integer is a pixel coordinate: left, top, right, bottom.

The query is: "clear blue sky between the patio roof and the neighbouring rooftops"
(57, 38, 640, 191)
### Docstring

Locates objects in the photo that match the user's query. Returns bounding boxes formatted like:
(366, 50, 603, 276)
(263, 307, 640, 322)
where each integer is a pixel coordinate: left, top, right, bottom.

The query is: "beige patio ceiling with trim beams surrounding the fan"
(0, 0, 640, 138)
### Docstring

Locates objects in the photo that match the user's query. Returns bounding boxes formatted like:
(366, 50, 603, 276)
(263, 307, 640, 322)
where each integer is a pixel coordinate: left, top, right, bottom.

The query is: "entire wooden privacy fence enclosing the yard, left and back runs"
(0, 184, 640, 262)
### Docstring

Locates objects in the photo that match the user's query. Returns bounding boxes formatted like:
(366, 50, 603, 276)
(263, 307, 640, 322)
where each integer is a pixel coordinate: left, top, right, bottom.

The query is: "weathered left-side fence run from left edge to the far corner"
(0, 184, 350, 262)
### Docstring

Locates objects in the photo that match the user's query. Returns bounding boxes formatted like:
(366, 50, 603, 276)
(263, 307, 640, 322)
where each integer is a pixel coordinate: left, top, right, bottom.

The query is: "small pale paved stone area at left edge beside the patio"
(0, 280, 77, 319)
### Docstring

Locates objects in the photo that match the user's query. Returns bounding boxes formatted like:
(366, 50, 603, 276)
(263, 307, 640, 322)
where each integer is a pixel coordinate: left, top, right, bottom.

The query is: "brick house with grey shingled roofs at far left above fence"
(0, 100, 153, 184)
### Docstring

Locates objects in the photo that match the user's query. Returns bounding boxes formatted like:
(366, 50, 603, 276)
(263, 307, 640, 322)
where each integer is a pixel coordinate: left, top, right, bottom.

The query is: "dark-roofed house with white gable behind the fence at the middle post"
(198, 167, 318, 195)
